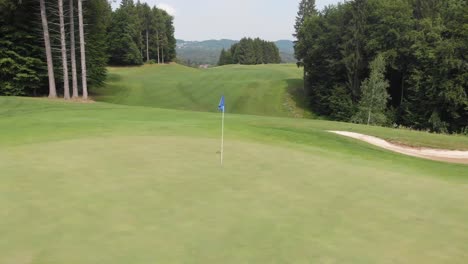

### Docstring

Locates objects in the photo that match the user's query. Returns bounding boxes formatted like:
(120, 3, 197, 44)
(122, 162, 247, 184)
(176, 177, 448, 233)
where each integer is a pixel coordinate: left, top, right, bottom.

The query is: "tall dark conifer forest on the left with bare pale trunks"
(0, 0, 176, 99)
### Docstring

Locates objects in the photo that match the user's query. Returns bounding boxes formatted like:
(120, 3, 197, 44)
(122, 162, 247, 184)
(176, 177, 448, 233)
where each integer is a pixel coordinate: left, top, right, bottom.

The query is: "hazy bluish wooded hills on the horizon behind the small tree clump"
(176, 39, 296, 66)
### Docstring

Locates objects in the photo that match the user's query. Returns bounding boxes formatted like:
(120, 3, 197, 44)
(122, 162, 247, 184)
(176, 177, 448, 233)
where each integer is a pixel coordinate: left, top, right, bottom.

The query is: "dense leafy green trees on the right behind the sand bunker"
(295, 0, 468, 133)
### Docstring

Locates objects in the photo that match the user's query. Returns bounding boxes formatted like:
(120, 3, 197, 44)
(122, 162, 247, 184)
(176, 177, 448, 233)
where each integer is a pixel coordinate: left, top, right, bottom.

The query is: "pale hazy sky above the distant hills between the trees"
(112, 0, 340, 41)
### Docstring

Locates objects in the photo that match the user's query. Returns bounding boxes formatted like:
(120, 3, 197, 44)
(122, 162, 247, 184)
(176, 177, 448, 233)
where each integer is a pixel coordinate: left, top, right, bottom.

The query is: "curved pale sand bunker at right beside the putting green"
(329, 131, 468, 164)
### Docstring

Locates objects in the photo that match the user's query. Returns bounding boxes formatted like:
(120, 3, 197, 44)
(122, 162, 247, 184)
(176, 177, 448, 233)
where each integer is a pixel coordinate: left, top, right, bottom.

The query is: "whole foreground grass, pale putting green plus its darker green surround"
(0, 97, 468, 264)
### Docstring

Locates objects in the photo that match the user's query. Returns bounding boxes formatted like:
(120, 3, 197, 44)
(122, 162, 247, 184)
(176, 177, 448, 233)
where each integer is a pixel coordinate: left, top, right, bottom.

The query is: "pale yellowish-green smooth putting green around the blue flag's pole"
(0, 136, 468, 263)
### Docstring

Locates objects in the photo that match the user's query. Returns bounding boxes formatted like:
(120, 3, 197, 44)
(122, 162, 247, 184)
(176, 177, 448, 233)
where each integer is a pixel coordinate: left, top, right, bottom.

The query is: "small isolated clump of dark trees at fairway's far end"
(218, 38, 281, 66)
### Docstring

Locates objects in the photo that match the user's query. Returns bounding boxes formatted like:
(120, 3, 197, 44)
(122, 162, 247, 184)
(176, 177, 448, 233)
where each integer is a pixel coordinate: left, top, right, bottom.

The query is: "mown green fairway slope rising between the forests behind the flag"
(95, 64, 304, 116)
